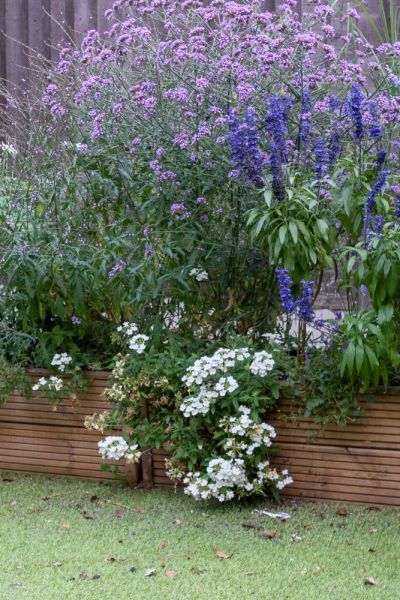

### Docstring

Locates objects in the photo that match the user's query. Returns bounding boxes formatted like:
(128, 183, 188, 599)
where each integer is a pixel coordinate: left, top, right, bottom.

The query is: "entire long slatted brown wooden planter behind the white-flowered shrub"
(0, 372, 400, 506)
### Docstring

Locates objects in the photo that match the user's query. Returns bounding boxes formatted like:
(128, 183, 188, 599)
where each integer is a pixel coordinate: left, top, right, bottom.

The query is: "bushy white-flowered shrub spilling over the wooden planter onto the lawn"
(86, 323, 292, 502)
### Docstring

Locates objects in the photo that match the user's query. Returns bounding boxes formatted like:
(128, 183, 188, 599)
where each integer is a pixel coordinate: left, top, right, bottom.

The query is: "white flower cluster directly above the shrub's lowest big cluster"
(220, 406, 276, 458)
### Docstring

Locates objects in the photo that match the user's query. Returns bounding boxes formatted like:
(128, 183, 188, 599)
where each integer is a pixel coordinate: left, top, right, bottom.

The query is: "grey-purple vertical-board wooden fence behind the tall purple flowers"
(0, 0, 387, 94)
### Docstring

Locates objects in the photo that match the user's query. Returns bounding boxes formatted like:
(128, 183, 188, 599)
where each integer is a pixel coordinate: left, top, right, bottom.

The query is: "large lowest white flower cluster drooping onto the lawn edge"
(183, 458, 252, 502)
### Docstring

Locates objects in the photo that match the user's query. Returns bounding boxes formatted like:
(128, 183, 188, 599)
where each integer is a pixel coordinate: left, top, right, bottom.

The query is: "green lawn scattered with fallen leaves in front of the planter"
(0, 473, 400, 600)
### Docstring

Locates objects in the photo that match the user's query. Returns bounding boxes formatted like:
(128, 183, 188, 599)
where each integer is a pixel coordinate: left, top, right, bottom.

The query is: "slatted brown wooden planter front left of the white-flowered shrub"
(0, 370, 115, 479)
